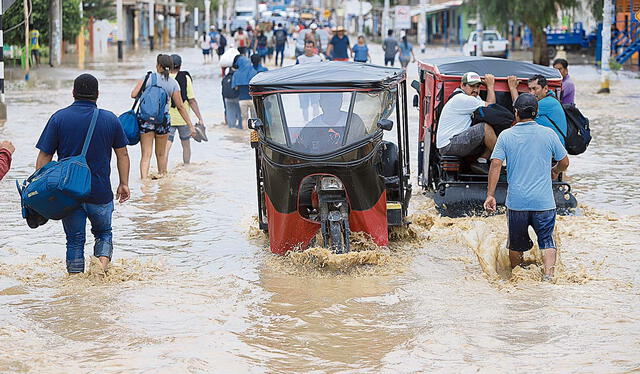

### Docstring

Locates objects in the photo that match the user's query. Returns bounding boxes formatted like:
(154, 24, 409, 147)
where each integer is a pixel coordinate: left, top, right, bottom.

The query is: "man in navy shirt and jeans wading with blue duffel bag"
(36, 74, 130, 274)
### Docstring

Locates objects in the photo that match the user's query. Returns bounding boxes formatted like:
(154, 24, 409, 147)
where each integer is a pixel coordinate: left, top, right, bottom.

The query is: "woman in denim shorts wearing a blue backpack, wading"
(131, 54, 193, 179)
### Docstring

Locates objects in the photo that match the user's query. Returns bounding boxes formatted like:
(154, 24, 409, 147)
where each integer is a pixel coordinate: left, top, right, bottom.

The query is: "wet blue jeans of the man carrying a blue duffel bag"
(62, 201, 113, 273)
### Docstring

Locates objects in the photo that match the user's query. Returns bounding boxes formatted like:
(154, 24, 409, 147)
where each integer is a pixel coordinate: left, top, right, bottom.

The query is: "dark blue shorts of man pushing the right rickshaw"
(507, 209, 556, 252)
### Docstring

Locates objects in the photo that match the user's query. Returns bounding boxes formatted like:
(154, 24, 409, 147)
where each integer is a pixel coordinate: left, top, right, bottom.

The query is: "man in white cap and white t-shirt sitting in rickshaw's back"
(436, 72, 497, 174)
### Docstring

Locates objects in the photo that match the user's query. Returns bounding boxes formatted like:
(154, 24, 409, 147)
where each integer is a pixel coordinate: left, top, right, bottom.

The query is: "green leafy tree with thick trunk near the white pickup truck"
(469, 0, 577, 66)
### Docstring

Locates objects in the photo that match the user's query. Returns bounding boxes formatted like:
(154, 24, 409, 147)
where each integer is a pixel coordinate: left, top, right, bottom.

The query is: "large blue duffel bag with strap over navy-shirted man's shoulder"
(16, 108, 100, 219)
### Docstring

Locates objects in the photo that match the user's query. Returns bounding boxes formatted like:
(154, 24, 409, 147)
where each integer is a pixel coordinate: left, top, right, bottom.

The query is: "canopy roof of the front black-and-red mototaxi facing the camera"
(249, 61, 405, 93)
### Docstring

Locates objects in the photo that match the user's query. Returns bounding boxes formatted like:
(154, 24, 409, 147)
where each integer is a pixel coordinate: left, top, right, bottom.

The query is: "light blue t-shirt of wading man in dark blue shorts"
(491, 121, 567, 211)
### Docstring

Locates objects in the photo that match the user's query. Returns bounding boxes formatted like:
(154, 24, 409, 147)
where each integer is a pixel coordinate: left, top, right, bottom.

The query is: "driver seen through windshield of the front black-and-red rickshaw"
(293, 93, 366, 154)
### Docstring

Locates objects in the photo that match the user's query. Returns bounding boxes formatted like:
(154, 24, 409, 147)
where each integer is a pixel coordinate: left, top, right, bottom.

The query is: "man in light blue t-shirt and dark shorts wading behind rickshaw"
(484, 93, 569, 281)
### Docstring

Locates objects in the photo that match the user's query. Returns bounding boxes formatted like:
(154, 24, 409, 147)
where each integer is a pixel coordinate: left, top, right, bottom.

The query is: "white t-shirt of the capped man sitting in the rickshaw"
(436, 89, 486, 148)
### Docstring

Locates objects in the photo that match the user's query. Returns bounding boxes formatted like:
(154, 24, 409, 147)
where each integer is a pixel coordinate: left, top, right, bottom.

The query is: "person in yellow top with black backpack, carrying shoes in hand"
(166, 54, 204, 164)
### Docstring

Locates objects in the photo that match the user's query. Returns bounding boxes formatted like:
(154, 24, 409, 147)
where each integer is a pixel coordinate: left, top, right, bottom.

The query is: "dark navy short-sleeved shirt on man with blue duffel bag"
(36, 100, 128, 204)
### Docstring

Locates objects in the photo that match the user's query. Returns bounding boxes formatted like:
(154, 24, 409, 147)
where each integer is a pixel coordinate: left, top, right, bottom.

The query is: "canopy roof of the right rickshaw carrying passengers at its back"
(423, 56, 562, 79)
